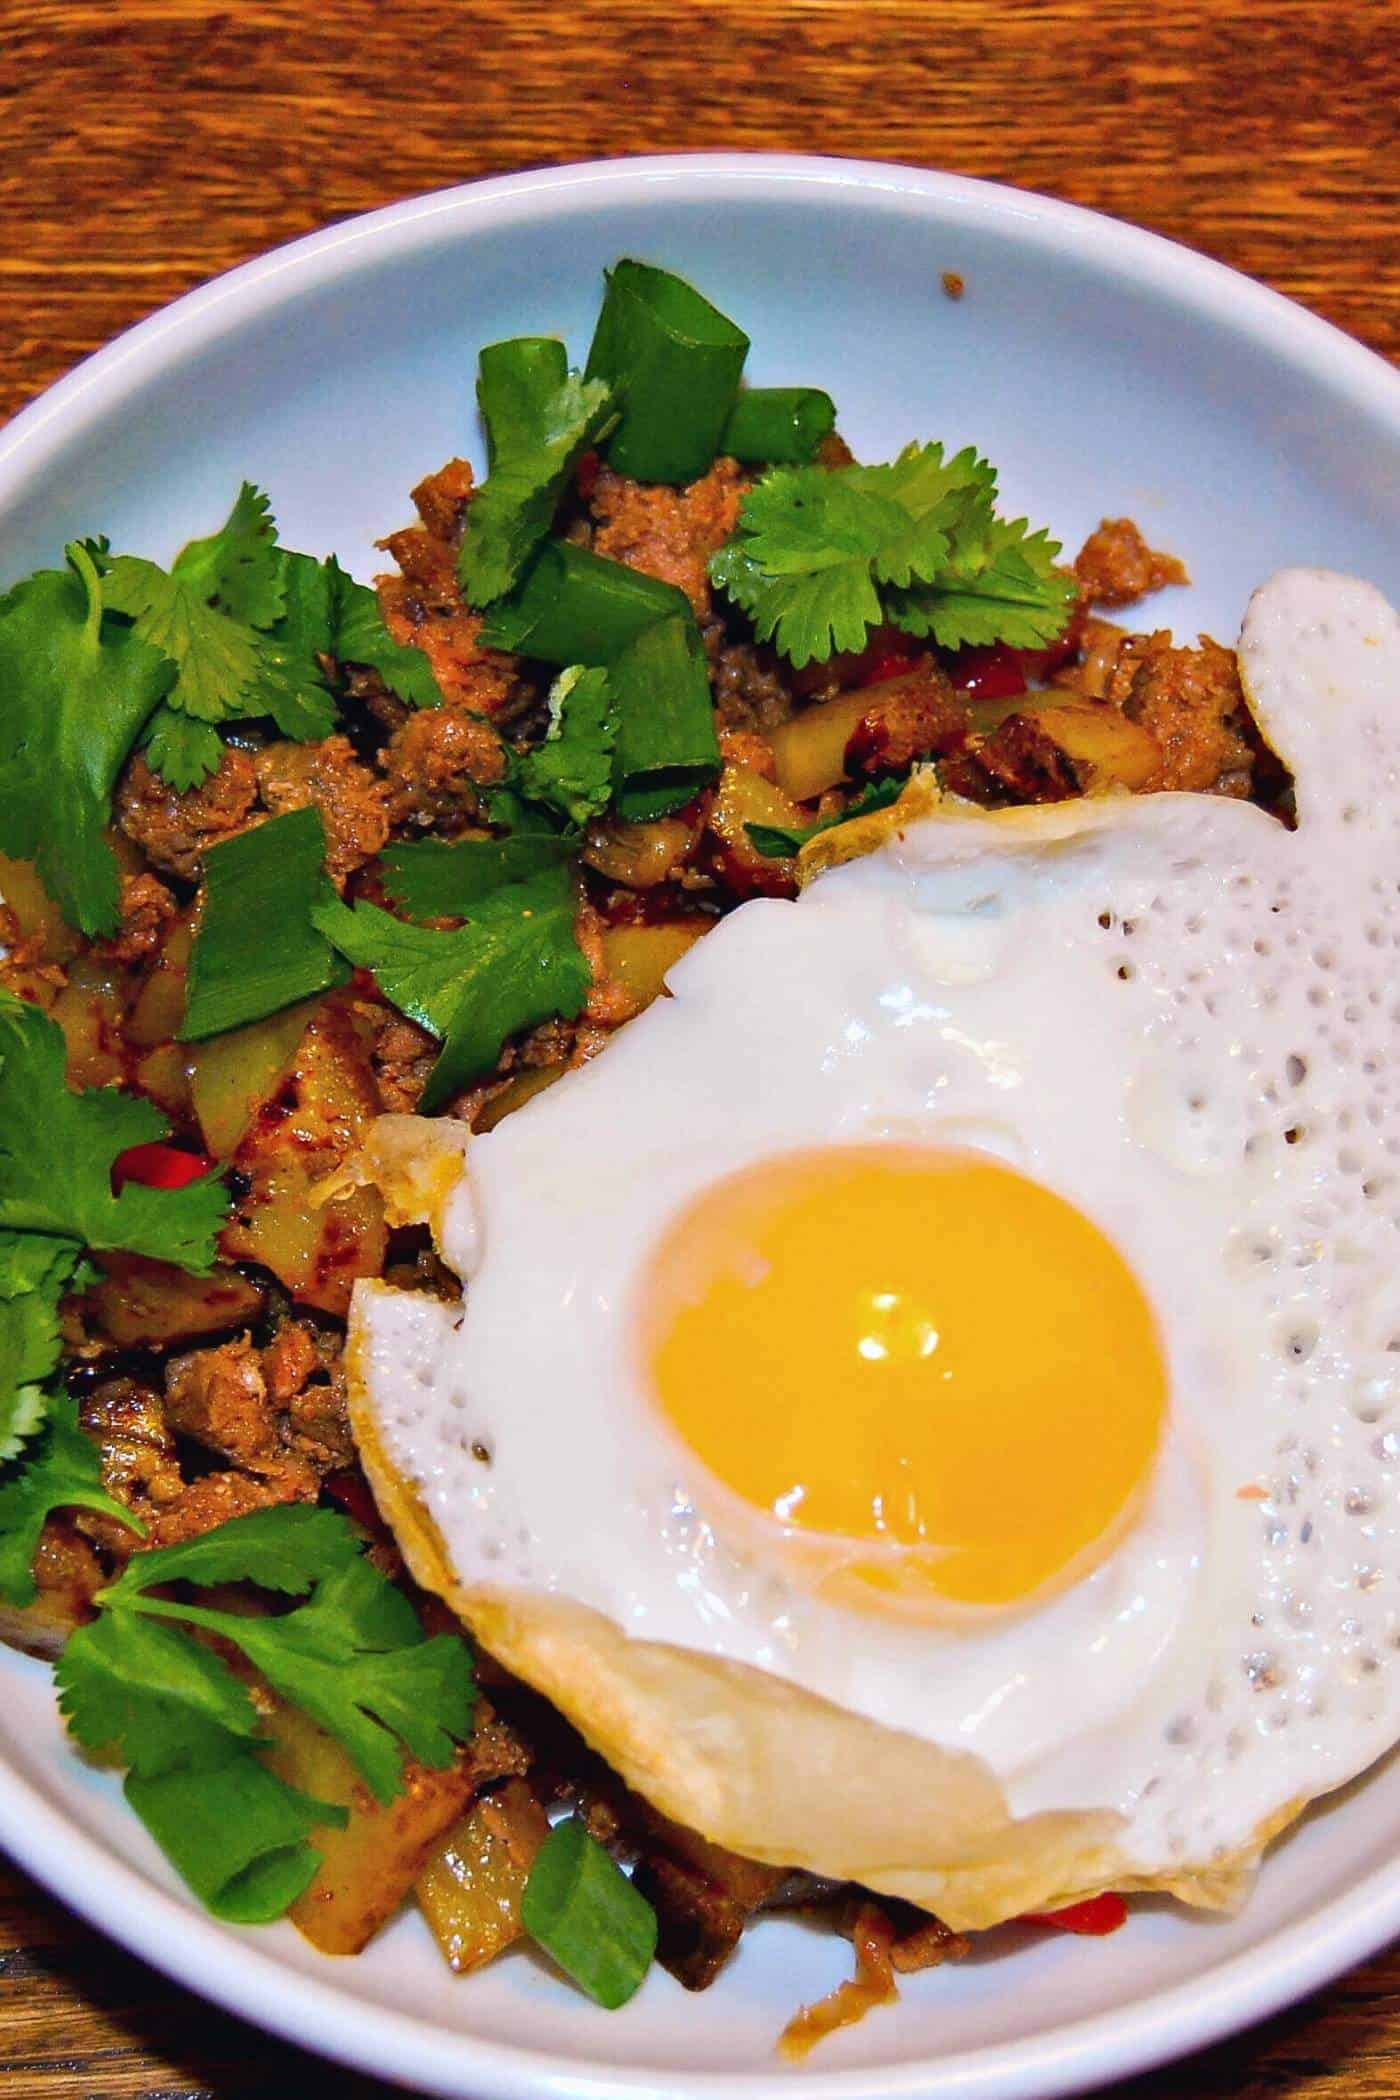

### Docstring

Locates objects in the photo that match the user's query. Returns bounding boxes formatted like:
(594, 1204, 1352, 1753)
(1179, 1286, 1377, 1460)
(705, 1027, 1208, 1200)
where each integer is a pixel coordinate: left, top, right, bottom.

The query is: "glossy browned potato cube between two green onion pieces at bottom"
(413, 1779, 550, 1976)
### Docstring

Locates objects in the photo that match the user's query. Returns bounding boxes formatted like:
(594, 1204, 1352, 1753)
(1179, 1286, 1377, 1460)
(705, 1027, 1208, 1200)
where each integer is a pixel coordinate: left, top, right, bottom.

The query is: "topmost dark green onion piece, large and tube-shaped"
(588, 263, 749, 483)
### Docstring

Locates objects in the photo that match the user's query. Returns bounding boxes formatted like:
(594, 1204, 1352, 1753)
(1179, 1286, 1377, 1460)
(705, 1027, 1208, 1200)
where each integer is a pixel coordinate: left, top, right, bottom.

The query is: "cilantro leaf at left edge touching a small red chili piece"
(0, 991, 229, 1275)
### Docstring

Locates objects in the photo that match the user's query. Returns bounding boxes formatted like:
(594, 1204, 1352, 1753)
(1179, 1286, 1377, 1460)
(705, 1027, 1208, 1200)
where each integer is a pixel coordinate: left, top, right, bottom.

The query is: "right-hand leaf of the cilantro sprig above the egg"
(886, 508, 1075, 649)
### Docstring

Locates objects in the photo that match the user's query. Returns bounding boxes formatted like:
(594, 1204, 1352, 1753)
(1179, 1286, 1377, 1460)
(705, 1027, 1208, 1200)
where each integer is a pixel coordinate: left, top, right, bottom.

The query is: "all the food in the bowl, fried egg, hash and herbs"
(0, 265, 1396, 2039)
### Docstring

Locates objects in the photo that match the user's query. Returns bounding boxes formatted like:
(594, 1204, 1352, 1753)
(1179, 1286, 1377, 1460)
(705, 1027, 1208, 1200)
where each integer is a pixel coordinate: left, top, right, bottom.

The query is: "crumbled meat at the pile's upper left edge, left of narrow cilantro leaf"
(378, 460, 521, 714)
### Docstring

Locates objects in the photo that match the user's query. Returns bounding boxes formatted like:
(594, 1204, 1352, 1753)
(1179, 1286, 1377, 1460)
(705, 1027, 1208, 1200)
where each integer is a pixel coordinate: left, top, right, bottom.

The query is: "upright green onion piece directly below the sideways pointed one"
(609, 605, 720, 823)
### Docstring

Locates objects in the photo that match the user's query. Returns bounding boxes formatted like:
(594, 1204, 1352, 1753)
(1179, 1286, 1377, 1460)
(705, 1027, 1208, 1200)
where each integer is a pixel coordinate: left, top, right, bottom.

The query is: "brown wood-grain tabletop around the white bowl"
(0, 0, 1400, 2100)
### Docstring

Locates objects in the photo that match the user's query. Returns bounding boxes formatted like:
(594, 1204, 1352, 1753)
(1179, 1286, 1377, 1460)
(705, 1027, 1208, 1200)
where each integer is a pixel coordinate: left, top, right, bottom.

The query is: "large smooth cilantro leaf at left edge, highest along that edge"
(0, 546, 172, 935)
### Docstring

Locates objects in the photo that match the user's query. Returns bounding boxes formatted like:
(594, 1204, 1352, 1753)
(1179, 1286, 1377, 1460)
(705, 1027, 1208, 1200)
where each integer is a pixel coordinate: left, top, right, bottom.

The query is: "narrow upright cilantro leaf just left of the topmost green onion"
(458, 352, 617, 605)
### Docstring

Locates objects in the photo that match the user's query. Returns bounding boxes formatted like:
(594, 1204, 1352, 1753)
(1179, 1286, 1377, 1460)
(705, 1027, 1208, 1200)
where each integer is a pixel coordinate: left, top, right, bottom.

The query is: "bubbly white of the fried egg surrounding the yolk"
(363, 571, 1400, 1871)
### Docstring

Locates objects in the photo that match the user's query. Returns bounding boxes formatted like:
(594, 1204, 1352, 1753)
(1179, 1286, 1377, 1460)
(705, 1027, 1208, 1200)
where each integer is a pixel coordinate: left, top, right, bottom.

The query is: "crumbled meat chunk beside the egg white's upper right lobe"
(1108, 628, 1251, 796)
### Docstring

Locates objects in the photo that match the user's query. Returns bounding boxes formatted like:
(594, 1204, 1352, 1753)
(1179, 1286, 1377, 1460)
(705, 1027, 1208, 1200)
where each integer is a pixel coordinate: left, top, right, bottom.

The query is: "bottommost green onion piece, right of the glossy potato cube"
(521, 1817, 657, 2012)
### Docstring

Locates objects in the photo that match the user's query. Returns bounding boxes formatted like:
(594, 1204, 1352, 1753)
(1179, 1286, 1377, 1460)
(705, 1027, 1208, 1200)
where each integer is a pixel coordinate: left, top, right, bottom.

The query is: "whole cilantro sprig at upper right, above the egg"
(709, 445, 1073, 666)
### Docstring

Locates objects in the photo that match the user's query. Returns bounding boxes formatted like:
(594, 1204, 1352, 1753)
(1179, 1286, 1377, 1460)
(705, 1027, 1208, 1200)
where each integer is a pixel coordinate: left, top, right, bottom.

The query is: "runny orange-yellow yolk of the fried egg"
(642, 1147, 1167, 1609)
